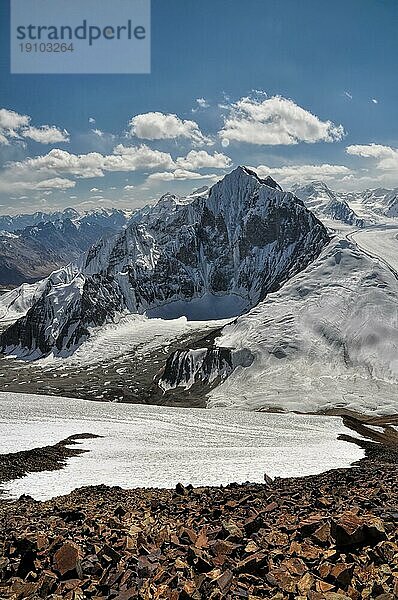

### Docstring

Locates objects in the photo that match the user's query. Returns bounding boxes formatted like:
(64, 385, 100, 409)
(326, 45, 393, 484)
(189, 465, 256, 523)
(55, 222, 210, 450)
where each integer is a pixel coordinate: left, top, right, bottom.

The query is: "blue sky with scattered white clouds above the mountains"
(0, 0, 398, 213)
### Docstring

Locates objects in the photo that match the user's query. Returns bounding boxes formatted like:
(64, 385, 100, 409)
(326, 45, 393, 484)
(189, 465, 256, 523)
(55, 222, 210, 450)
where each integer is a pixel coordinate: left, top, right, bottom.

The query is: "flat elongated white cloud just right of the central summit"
(254, 164, 352, 185)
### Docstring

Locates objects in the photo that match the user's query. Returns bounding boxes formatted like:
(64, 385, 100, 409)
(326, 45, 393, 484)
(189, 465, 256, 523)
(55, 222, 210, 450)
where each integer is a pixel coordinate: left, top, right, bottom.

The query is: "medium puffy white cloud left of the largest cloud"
(129, 112, 212, 145)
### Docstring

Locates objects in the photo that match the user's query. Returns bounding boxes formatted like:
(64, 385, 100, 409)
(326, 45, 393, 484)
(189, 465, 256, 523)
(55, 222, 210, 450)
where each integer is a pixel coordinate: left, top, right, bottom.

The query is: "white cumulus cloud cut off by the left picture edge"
(0, 108, 69, 145)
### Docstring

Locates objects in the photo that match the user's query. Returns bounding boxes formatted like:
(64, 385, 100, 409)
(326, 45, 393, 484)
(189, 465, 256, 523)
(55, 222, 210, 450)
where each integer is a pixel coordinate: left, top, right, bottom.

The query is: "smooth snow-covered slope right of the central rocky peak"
(208, 238, 398, 414)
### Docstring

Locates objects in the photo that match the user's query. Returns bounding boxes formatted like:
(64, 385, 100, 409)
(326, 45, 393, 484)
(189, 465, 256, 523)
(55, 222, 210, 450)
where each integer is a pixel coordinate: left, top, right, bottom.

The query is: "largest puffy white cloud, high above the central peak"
(219, 96, 344, 147)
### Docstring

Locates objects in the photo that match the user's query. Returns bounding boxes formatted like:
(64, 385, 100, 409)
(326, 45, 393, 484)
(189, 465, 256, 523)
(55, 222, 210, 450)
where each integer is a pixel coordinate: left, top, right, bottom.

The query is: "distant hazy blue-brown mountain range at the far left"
(0, 209, 127, 287)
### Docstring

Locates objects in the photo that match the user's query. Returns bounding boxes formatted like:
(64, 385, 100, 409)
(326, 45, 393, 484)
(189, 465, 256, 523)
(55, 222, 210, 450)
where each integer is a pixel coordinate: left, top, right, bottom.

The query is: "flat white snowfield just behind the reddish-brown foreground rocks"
(0, 393, 363, 500)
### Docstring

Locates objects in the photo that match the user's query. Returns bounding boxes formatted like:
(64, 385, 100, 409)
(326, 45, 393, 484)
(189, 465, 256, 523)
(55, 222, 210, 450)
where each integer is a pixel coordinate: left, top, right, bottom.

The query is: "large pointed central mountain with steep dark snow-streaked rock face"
(0, 167, 329, 357)
